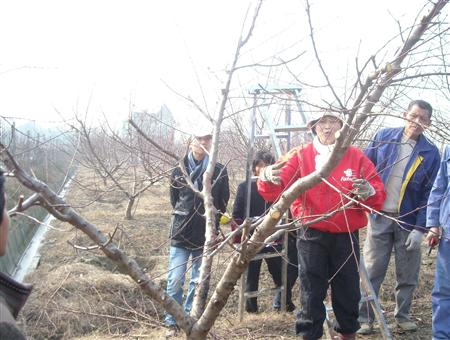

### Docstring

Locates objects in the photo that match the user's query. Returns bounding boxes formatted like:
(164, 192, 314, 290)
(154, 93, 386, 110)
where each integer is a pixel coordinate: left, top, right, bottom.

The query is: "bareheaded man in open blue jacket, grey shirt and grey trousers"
(358, 100, 440, 334)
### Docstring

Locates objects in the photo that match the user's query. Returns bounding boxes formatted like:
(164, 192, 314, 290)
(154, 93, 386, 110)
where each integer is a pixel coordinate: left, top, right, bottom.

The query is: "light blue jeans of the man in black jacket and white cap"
(164, 246, 203, 326)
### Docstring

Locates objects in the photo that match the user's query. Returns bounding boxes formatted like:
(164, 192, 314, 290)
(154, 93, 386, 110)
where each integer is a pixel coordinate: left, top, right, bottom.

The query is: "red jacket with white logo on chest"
(257, 143, 386, 233)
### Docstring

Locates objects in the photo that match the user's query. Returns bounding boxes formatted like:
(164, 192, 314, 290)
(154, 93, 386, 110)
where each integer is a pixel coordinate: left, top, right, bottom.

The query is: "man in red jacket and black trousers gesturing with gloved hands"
(258, 112, 386, 339)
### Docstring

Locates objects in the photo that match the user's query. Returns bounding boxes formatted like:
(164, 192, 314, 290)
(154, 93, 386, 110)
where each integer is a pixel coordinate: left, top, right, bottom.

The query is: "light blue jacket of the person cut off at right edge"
(427, 145, 450, 234)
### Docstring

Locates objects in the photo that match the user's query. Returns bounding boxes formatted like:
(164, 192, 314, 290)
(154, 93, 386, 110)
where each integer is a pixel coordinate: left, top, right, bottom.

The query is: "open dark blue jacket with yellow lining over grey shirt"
(365, 127, 440, 232)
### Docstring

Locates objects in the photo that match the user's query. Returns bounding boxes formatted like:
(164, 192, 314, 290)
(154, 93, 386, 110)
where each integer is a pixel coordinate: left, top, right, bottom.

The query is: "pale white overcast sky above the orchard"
(0, 0, 440, 131)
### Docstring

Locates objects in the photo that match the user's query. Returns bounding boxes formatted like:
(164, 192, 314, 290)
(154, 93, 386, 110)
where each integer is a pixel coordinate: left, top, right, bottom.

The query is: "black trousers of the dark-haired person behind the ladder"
(245, 235, 298, 313)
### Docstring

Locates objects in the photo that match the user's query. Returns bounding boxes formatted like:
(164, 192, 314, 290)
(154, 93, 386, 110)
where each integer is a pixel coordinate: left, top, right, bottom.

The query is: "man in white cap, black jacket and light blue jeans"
(165, 129, 230, 337)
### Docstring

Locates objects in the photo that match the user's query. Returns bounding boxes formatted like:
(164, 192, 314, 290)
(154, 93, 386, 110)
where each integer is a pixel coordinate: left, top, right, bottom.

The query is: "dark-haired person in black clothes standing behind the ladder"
(233, 150, 297, 313)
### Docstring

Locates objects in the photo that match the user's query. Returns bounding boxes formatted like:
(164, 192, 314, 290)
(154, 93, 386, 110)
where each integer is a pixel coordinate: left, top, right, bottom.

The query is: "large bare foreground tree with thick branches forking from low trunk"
(1, 0, 448, 339)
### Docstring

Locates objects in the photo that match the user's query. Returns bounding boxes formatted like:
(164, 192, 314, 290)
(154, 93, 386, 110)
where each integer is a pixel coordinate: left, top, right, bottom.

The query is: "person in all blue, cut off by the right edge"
(427, 145, 450, 340)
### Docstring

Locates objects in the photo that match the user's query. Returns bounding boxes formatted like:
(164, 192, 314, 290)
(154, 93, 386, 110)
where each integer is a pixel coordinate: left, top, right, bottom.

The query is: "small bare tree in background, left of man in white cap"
(72, 114, 176, 220)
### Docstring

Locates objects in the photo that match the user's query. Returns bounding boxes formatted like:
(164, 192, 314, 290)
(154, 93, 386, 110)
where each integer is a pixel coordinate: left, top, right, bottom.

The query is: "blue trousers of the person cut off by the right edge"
(431, 234, 450, 340)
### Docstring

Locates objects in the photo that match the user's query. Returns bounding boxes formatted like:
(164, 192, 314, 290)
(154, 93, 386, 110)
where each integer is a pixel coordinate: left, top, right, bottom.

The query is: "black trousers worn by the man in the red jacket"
(296, 228, 361, 339)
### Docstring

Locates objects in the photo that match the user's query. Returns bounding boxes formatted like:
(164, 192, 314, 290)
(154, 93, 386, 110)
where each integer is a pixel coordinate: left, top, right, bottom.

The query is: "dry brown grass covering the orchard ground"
(20, 166, 435, 340)
